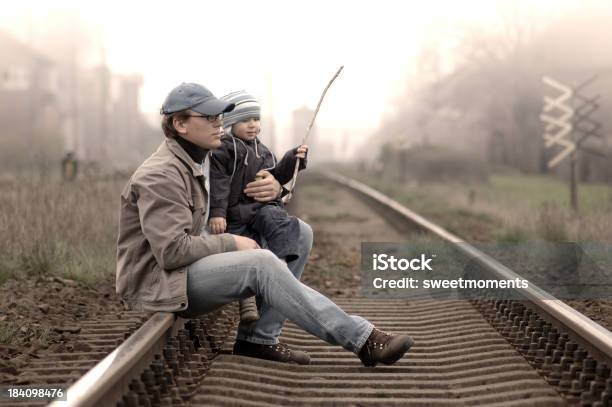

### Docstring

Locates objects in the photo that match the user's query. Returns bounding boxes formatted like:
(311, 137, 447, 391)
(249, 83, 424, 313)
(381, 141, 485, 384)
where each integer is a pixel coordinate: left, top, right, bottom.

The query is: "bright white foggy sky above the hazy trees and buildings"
(0, 0, 596, 153)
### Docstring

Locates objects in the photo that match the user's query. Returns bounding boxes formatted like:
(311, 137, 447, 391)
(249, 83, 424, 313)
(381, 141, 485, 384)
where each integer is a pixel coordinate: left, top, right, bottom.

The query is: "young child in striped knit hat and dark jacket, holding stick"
(208, 91, 308, 323)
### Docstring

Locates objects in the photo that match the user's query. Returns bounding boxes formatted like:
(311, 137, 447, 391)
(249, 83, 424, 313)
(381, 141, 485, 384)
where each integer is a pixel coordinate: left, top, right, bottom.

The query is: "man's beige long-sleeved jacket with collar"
(116, 138, 236, 311)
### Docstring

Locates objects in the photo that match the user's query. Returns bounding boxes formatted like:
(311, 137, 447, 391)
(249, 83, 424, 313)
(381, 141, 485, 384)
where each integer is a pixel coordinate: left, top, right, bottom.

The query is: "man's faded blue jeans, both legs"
(179, 220, 373, 353)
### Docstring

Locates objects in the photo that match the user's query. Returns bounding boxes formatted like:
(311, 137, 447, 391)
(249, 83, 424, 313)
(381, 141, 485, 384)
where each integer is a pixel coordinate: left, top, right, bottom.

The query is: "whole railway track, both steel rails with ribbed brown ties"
(9, 174, 612, 407)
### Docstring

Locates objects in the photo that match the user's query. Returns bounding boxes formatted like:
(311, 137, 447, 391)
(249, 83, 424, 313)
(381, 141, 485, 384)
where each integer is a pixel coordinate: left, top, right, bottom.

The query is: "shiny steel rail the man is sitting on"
(50, 312, 176, 407)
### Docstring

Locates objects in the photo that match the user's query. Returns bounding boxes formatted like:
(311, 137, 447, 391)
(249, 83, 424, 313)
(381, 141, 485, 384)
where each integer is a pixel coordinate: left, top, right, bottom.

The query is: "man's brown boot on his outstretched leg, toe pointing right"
(358, 328, 414, 367)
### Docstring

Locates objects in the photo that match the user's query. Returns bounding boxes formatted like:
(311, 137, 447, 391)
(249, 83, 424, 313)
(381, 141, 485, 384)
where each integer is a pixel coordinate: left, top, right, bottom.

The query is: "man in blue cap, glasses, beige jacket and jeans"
(117, 83, 412, 366)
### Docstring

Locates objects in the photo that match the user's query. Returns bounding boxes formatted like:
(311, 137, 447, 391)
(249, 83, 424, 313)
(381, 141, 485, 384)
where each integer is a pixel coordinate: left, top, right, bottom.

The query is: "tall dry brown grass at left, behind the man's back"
(0, 174, 125, 284)
